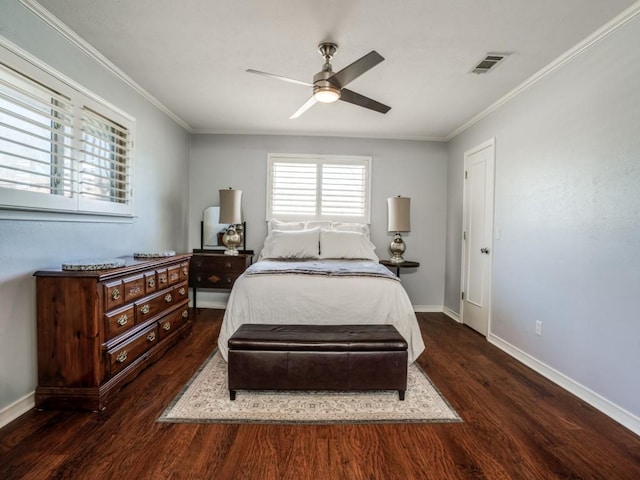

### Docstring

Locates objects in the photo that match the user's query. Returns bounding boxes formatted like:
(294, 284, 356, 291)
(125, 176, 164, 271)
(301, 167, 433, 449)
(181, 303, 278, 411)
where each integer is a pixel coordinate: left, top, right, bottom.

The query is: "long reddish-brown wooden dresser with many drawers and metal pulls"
(34, 255, 192, 410)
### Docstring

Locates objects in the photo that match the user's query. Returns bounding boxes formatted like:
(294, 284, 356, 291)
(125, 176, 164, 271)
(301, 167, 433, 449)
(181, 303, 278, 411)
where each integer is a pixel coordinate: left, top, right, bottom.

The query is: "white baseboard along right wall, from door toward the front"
(487, 333, 640, 435)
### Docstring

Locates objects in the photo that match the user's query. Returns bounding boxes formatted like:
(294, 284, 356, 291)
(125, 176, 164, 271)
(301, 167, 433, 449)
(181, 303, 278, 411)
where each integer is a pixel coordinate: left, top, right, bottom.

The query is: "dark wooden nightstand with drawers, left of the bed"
(189, 249, 253, 309)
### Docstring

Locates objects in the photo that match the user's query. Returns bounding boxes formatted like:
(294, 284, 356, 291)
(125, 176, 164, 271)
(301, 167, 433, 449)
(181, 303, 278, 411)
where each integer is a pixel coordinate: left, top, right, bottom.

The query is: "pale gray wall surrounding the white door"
(445, 16, 640, 421)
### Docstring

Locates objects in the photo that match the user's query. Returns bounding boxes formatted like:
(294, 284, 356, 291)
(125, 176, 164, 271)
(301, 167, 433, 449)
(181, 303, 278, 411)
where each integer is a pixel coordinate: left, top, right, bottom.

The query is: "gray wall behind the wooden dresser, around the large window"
(0, 1, 189, 413)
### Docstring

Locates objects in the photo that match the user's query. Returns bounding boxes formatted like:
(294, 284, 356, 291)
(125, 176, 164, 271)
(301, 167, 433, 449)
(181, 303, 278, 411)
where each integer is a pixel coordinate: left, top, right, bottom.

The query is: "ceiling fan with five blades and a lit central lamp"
(247, 42, 391, 118)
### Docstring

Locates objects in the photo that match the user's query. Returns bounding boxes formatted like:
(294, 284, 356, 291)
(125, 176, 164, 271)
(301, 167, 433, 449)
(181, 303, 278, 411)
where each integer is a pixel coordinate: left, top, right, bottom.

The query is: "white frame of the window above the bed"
(266, 153, 373, 224)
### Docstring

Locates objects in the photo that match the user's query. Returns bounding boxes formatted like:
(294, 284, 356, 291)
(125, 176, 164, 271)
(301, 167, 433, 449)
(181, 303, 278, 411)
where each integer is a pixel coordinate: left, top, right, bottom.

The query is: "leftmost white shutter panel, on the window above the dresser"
(0, 64, 74, 208)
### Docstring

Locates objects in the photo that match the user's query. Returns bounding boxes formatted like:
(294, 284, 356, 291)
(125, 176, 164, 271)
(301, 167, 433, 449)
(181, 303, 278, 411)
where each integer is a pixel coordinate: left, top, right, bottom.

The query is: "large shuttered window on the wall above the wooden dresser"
(0, 46, 133, 216)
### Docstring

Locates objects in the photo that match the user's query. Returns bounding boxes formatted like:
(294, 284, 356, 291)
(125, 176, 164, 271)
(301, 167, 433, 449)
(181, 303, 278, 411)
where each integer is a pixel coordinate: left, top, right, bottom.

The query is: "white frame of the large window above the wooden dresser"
(0, 37, 135, 221)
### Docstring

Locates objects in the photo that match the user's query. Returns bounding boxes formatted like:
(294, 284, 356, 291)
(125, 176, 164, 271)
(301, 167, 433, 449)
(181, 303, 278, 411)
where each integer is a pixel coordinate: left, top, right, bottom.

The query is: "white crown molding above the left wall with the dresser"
(18, 0, 193, 133)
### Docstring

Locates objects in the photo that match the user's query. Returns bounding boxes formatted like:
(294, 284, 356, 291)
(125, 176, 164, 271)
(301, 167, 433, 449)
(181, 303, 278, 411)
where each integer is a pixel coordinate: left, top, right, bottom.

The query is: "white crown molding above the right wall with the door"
(444, 1, 640, 142)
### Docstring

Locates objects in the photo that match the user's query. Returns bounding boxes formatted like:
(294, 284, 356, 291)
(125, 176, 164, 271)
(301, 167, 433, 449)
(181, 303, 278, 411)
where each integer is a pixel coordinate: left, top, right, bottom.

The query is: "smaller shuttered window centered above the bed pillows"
(267, 154, 371, 223)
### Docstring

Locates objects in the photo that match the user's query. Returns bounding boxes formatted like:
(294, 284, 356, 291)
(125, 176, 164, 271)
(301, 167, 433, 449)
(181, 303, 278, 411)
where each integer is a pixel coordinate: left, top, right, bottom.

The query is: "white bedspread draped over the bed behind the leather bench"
(218, 260, 424, 363)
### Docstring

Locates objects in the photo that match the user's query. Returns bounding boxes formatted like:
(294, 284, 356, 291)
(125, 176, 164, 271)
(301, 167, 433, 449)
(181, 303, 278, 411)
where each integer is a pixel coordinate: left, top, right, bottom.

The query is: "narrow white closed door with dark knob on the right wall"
(461, 139, 495, 336)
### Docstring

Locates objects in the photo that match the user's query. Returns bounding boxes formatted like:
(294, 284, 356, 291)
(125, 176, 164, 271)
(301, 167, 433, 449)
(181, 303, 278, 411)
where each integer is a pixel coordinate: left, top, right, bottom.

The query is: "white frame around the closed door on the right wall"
(460, 137, 496, 337)
